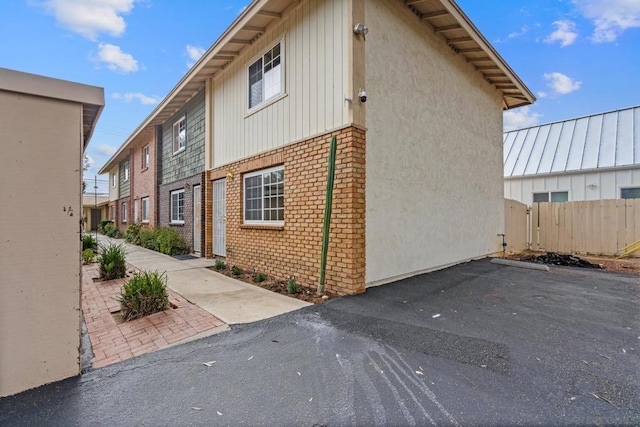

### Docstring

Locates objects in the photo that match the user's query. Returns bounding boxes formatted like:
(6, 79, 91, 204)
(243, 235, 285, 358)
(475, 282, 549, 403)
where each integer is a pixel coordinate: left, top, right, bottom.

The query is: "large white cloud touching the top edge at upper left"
(40, 0, 136, 40)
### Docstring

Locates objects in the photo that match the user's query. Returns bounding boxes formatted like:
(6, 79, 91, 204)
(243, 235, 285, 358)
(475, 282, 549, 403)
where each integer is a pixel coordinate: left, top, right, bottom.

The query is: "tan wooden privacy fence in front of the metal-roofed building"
(505, 199, 640, 255)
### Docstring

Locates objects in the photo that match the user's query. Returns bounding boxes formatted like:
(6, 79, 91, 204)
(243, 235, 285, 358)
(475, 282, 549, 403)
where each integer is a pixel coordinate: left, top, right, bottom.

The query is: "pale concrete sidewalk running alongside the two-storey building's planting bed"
(98, 235, 311, 325)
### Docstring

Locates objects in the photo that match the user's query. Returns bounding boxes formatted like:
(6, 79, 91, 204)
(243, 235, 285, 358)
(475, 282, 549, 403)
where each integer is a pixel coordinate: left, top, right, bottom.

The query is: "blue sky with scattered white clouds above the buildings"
(0, 0, 640, 189)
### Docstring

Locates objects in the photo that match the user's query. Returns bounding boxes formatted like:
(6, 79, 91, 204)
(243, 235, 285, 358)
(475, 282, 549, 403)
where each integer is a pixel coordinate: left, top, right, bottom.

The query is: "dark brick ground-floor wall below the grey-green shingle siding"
(158, 174, 204, 253)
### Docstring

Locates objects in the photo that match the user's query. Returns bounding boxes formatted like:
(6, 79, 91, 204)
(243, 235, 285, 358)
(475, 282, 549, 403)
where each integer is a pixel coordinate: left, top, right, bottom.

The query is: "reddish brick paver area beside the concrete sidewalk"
(82, 264, 224, 368)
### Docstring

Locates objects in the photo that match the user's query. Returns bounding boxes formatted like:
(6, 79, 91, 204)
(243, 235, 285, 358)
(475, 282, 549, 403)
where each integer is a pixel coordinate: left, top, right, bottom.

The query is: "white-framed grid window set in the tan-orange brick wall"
(243, 166, 284, 225)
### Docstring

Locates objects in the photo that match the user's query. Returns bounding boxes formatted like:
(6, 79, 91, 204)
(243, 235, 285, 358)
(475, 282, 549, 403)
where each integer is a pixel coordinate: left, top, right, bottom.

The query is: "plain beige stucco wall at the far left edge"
(0, 90, 83, 397)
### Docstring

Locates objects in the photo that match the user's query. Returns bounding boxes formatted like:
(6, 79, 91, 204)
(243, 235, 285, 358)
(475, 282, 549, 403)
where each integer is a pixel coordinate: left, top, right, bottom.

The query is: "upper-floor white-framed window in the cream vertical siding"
(247, 41, 284, 110)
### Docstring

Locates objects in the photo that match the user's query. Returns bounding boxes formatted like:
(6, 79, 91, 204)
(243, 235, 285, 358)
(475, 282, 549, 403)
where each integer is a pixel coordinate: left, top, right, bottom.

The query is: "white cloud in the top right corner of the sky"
(573, 0, 640, 43)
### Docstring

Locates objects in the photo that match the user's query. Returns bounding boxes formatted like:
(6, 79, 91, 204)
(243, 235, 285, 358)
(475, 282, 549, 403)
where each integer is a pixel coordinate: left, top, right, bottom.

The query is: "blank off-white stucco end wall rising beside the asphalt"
(365, 1, 504, 285)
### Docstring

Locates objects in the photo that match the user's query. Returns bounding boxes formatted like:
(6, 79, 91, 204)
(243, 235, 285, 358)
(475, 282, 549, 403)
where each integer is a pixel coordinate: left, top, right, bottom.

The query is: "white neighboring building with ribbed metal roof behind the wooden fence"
(504, 106, 640, 204)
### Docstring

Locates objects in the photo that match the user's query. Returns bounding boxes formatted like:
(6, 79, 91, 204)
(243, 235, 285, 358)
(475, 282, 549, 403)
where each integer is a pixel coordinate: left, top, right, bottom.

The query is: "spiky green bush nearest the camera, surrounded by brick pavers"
(118, 271, 169, 321)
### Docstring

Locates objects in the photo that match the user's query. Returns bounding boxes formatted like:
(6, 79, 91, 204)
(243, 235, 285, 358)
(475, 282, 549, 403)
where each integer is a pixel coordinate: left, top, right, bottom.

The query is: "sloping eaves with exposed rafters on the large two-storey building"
(110, 0, 535, 169)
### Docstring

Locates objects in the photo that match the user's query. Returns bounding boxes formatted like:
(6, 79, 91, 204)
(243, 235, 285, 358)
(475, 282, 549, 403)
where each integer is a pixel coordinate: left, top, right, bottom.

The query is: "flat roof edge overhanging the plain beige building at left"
(0, 68, 104, 148)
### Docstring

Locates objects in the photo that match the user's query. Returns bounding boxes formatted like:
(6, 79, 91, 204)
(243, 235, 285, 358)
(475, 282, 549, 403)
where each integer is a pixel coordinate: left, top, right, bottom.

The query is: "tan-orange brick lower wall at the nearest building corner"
(203, 127, 366, 294)
